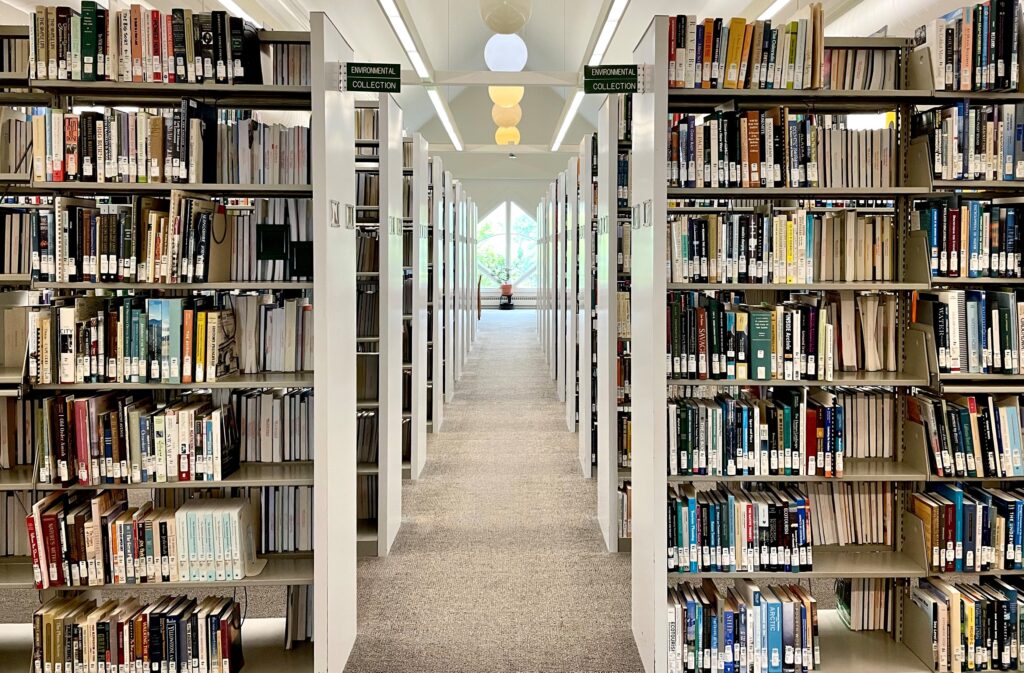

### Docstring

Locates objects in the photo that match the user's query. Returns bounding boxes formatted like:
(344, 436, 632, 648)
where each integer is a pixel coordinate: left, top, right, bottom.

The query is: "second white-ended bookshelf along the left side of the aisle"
(353, 94, 404, 556)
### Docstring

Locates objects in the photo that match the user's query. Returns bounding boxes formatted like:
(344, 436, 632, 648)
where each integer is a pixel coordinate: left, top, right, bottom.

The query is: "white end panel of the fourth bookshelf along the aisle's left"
(427, 156, 446, 432)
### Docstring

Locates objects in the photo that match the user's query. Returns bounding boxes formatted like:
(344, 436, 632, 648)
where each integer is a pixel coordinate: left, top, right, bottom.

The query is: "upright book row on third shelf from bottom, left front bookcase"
(32, 392, 239, 487)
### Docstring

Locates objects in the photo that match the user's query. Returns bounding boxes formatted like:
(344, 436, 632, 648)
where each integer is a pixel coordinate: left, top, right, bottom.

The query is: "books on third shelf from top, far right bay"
(915, 196, 1024, 278)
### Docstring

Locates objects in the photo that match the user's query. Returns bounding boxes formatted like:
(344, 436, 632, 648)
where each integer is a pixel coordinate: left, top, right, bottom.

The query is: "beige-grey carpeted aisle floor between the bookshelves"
(346, 310, 642, 673)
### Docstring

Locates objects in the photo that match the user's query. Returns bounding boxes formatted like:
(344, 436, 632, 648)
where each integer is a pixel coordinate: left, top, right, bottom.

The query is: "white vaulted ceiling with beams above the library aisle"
(0, 0, 963, 212)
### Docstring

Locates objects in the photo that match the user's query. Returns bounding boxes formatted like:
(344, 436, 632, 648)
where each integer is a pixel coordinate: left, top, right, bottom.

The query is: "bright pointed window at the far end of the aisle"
(476, 201, 537, 290)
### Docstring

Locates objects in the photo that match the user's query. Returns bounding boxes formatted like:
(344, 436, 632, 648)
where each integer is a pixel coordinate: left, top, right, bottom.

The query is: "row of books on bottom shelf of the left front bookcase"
(32, 596, 245, 673)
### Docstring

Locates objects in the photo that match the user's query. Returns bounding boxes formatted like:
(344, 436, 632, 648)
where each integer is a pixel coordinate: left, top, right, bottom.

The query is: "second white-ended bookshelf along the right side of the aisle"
(594, 95, 631, 551)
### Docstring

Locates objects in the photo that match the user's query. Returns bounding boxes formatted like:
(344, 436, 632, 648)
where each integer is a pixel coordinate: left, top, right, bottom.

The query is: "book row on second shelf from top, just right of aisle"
(668, 112, 896, 188)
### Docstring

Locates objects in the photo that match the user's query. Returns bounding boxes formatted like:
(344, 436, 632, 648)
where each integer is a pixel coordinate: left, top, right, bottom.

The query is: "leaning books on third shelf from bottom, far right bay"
(907, 391, 1024, 478)
